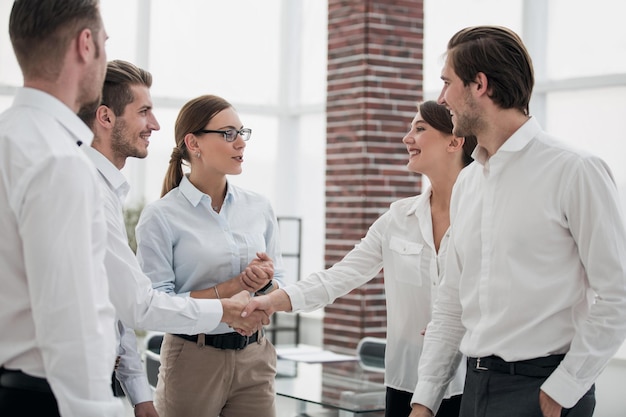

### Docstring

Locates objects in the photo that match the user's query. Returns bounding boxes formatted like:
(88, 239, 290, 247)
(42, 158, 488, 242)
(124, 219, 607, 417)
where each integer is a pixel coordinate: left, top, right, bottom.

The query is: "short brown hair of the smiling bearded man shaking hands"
(78, 60, 152, 127)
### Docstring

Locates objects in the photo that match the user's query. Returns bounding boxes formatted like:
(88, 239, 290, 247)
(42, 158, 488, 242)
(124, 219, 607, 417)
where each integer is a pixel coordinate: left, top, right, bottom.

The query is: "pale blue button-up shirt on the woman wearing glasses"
(136, 176, 284, 334)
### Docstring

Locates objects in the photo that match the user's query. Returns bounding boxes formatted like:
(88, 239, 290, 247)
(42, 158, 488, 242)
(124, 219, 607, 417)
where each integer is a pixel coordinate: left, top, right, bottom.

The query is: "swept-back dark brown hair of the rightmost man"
(448, 26, 535, 115)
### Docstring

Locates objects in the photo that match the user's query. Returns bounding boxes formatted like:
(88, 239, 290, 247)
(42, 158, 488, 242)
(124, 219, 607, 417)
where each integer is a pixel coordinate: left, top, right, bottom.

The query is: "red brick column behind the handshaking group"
(324, 0, 423, 353)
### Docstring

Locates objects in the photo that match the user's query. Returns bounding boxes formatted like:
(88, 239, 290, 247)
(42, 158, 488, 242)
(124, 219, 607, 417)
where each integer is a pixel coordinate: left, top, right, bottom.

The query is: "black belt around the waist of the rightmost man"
(467, 355, 565, 378)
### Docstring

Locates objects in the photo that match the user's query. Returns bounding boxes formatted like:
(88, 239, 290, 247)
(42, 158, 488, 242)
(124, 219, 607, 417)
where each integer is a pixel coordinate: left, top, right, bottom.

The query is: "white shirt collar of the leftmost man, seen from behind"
(13, 87, 93, 146)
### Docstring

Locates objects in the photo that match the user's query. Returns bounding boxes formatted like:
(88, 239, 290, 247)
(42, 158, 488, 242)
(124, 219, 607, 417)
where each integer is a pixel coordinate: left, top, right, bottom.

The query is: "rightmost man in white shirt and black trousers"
(411, 26, 626, 417)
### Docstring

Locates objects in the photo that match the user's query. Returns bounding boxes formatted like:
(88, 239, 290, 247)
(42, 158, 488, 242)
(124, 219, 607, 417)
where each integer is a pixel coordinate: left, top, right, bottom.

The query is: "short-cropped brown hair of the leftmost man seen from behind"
(9, 0, 102, 81)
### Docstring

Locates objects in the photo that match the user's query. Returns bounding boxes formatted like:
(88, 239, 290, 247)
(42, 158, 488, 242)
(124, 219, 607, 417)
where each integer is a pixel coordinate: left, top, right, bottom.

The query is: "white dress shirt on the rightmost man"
(413, 118, 626, 408)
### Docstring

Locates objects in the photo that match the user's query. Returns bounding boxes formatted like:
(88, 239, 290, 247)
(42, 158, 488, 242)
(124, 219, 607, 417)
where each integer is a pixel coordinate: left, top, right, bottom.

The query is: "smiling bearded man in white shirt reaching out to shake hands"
(79, 60, 267, 417)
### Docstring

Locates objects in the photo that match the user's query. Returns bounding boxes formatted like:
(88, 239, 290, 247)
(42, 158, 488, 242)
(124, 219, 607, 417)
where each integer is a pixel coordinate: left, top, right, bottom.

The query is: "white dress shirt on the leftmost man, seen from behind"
(0, 88, 123, 417)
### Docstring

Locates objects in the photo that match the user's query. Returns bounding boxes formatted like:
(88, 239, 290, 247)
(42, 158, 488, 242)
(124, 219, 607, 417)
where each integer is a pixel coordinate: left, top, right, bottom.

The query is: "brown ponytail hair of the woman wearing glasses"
(161, 95, 232, 197)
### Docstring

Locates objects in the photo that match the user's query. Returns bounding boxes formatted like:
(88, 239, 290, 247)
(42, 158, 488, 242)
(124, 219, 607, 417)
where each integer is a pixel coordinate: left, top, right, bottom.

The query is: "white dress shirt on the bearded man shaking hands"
(84, 146, 223, 405)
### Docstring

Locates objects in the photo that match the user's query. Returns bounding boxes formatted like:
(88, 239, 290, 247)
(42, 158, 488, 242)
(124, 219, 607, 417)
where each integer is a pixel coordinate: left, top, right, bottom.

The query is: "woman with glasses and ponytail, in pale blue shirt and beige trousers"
(136, 95, 283, 417)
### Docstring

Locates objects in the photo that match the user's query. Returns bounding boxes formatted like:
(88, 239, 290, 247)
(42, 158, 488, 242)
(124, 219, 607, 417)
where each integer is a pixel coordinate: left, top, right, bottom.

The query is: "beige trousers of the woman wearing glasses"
(154, 334, 276, 417)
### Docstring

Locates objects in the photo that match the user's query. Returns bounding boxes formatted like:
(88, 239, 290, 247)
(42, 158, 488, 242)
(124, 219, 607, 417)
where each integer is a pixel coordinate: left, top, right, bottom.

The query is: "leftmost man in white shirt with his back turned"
(0, 0, 124, 417)
